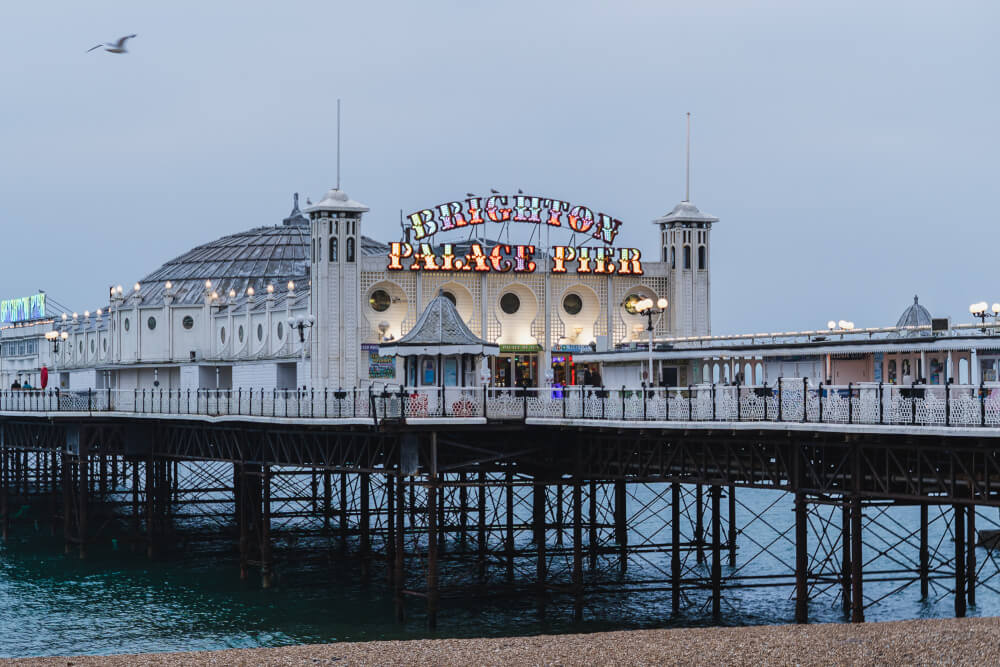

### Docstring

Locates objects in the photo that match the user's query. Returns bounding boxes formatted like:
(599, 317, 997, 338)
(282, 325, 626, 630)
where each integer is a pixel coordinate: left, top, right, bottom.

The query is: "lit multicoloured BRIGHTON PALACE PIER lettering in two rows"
(387, 194, 642, 275)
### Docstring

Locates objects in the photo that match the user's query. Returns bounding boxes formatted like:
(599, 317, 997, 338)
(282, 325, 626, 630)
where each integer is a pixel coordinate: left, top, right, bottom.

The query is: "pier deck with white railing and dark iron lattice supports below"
(0, 379, 1000, 628)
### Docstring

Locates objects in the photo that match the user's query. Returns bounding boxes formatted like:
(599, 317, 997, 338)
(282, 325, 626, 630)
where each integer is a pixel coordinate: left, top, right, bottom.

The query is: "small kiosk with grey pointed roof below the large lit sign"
(379, 291, 500, 387)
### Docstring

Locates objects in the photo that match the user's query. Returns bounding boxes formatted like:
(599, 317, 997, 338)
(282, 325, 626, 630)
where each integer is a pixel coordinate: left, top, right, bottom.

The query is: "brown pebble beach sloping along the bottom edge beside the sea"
(0, 617, 1000, 667)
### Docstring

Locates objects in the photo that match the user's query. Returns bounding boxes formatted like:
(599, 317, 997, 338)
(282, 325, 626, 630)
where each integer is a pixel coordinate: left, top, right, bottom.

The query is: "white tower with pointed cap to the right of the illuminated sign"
(653, 200, 719, 336)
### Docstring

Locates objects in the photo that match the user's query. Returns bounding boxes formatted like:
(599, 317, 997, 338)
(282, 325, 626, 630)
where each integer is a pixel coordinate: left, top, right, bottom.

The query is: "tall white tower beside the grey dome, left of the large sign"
(305, 188, 368, 389)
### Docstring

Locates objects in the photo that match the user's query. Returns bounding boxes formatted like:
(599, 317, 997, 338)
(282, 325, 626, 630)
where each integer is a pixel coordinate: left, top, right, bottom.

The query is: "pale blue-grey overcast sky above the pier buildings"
(0, 0, 1000, 334)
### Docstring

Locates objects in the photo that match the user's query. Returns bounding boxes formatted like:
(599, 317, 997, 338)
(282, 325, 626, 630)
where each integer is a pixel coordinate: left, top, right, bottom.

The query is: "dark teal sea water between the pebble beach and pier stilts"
(0, 491, 1000, 657)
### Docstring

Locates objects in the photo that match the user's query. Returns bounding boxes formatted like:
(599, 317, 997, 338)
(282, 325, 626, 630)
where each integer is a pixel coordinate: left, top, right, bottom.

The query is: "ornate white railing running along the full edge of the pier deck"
(0, 378, 1000, 427)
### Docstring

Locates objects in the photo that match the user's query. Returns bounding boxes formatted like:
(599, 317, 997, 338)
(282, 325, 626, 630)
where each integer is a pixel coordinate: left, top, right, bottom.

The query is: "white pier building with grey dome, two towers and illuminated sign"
(0, 183, 1000, 391)
